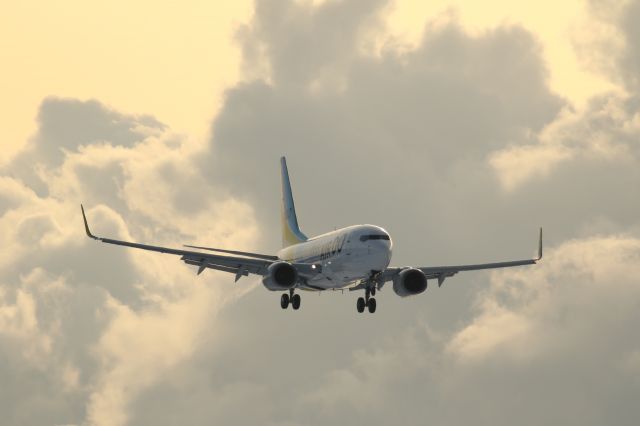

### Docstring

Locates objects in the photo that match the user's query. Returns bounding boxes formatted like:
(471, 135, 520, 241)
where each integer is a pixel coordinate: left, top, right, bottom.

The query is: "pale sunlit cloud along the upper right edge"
(489, 1, 640, 190)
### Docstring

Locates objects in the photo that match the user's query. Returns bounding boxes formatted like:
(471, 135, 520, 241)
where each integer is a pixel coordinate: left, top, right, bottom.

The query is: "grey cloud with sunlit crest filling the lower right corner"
(292, 235, 640, 425)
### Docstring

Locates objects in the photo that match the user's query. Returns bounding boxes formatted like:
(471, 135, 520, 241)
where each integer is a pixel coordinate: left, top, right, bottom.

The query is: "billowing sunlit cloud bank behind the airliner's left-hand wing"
(0, 98, 256, 425)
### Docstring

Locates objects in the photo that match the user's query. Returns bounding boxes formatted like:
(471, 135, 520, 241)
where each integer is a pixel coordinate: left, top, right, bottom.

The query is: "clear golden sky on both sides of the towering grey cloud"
(0, 0, 611, 161)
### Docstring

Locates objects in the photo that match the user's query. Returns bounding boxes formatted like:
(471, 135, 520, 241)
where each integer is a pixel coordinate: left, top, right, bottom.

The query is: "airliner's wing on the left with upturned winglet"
(80, 205, 317, 281)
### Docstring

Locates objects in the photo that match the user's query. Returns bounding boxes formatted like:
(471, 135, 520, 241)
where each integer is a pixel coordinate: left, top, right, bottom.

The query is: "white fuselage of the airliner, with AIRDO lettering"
(278, 225, 393, 290)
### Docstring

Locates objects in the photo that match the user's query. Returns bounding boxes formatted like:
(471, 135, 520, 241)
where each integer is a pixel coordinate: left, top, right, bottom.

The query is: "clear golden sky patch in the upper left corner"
(0, 0, 251, 161)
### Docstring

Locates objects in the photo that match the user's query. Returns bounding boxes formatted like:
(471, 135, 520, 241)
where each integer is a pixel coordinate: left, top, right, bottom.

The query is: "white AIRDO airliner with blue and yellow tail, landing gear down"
(80, 157, 542, 313)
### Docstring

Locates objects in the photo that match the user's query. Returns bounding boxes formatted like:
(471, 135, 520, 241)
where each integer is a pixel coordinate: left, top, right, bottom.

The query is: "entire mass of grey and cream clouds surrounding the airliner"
(0, 1, 640, 425)
